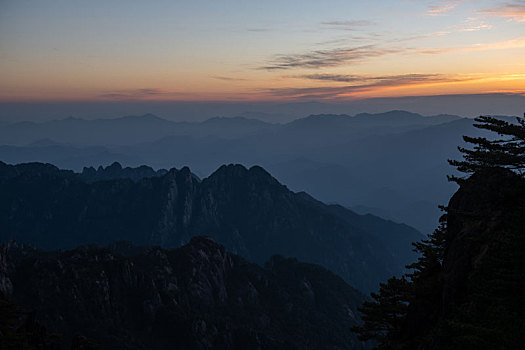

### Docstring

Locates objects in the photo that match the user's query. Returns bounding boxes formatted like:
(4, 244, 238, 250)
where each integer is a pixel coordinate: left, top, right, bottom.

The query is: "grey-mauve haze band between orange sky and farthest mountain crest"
(0, 93, 525, 123)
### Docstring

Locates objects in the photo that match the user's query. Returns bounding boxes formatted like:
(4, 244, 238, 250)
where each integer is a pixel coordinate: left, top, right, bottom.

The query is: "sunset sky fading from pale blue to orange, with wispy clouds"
(0, 0, 525, 102)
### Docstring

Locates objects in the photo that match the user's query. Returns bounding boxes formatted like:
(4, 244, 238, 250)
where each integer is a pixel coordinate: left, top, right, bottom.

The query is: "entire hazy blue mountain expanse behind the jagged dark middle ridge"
(0, 111, 508, 233)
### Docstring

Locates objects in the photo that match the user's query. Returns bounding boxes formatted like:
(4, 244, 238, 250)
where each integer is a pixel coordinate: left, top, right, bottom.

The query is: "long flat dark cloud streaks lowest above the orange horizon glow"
(264, 74, 480, 99)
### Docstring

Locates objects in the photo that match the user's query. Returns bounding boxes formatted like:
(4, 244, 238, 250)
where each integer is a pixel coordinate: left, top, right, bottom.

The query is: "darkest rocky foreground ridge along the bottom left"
(0, 237, 367, 350)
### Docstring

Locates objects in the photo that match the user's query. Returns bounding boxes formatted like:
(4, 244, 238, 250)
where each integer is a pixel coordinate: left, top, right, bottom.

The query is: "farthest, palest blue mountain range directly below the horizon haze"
(0, 111, 459, 146)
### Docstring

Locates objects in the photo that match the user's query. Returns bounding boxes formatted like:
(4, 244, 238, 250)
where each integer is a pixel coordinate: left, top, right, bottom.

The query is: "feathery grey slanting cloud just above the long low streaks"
(259, 45, 401, 70)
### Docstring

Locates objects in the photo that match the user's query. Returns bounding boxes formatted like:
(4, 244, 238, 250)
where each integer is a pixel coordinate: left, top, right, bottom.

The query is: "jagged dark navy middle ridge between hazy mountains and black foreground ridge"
(0, 163, 422, 292)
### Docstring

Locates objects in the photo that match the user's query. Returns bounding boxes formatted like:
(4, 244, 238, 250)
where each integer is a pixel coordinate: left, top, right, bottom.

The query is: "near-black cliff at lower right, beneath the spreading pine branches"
(391, 168, 525, 350)
